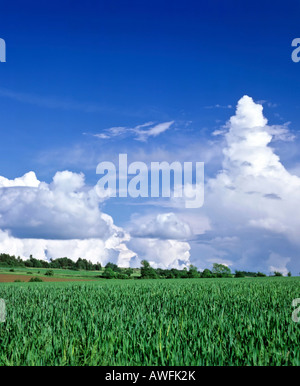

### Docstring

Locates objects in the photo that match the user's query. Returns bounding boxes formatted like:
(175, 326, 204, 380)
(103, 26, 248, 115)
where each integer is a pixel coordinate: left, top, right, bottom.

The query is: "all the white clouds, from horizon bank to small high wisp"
(0, 95, 300, 274)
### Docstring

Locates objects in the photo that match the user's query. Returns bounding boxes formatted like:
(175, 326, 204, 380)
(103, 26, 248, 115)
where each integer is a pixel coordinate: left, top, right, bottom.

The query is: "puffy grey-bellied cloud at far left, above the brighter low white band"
(0, 171, 115, 239)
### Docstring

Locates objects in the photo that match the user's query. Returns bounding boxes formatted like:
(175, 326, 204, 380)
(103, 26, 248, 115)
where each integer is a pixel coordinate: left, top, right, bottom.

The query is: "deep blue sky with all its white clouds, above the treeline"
(0, 0, 300, 275)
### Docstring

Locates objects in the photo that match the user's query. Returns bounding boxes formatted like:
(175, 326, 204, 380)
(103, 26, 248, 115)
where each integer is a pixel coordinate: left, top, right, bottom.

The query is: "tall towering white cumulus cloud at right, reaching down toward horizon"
(188, 96, 300, 270)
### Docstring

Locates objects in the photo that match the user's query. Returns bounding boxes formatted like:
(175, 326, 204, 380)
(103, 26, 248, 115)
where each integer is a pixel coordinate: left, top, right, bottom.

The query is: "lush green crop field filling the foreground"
(0, 277, 300, 366)
